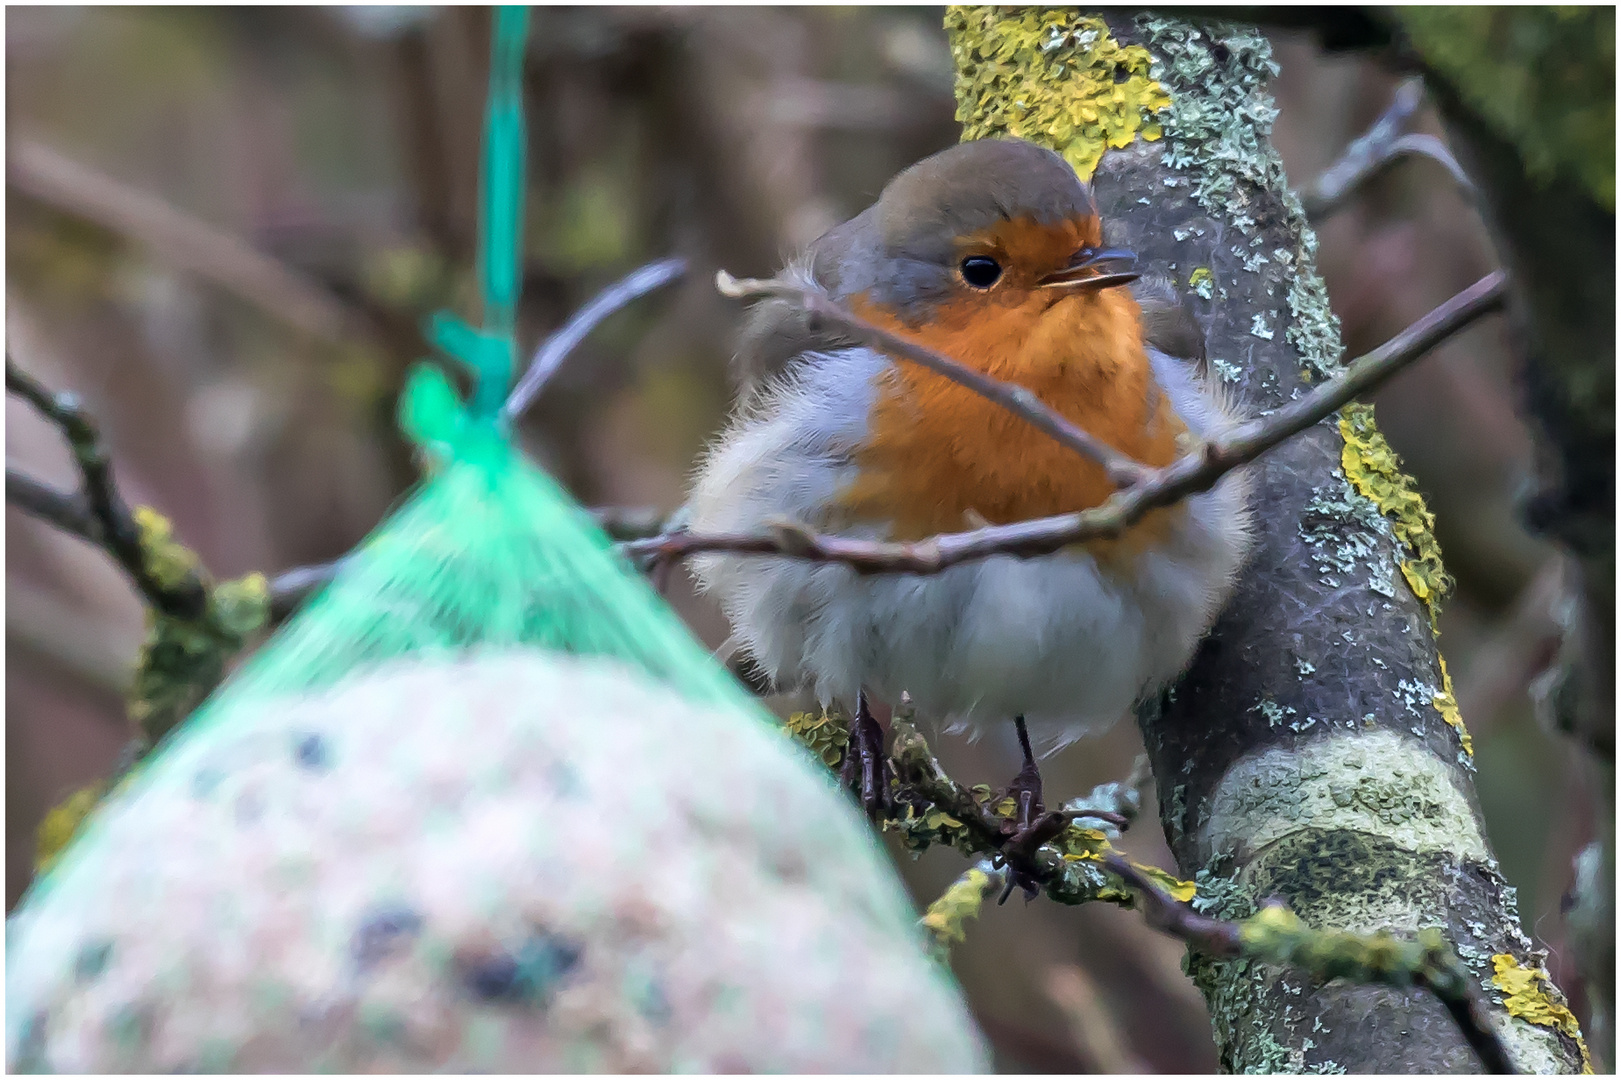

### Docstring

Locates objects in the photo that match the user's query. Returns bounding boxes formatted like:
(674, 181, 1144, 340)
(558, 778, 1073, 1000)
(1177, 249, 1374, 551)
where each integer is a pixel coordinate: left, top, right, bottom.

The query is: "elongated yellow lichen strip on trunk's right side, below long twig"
(1339, 404, 1452, 622)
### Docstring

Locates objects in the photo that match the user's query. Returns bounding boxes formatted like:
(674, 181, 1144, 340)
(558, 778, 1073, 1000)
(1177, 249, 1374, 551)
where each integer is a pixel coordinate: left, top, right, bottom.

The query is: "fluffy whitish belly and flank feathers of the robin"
(689, 349, 1248, 751)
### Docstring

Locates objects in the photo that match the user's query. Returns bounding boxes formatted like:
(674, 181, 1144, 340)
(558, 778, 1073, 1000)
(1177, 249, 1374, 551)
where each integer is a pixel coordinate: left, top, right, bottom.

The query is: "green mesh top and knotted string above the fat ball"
(147, 6, 747, 720)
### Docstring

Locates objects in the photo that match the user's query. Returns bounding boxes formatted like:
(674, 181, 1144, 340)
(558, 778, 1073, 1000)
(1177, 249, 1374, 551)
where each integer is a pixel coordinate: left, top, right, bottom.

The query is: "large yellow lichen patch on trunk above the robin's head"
(945, 6, 1170, 180)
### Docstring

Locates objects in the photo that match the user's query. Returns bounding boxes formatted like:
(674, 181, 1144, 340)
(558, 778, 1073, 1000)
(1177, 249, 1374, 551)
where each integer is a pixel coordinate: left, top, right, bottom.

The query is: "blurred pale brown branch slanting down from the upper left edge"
(6, 141, 371, 339)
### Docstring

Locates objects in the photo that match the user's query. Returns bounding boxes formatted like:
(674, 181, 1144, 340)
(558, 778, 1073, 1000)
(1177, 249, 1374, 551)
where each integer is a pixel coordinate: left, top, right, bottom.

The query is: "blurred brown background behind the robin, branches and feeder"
(6, 8, 1590, 1072)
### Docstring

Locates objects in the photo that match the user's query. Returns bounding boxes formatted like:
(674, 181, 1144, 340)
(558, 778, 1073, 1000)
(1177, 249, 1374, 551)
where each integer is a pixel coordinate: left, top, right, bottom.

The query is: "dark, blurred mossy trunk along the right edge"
(1392, 8, 1616, 1065)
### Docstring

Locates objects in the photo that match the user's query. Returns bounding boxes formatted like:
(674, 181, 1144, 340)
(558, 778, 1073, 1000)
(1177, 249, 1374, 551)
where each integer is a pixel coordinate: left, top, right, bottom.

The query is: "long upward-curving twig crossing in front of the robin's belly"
(622, 271, 1508, 574)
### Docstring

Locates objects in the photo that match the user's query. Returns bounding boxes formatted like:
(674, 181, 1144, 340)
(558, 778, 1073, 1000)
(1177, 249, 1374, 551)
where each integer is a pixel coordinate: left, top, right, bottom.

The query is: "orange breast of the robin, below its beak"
(841, 289, 1187, 555)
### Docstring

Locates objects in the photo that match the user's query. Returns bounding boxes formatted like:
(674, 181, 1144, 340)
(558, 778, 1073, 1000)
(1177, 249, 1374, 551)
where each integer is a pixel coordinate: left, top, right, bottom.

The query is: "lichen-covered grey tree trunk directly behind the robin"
(948, 10, 1582, 1072)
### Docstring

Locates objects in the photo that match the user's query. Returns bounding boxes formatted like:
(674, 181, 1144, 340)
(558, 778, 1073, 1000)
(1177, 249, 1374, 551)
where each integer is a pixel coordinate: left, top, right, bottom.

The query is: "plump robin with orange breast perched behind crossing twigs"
(689, 139, 1250, 827)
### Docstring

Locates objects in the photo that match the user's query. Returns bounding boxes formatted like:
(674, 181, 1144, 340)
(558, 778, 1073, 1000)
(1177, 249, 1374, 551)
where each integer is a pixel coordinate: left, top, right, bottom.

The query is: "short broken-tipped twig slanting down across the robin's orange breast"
(715, 271, 1148, 488)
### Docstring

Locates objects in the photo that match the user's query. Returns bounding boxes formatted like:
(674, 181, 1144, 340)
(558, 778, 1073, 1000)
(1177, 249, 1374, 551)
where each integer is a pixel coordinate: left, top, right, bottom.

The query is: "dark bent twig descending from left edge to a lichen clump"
(5, 354, 207, 619)
